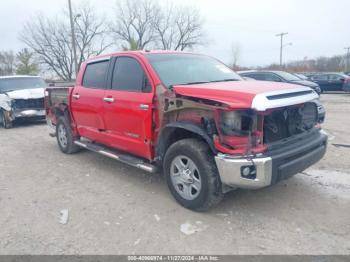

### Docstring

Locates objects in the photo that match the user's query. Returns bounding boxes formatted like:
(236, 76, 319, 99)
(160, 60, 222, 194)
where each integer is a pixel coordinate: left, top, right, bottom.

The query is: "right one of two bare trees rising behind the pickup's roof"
(154, 4, 204, 51)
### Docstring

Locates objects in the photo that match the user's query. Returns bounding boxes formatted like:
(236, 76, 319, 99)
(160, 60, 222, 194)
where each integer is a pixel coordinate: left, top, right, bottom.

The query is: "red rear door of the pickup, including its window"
(71, 59, 109, 142)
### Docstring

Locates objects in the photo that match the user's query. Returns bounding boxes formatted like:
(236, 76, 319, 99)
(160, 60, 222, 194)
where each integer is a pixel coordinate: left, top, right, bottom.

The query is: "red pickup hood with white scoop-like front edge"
(174, 81, 318, 111)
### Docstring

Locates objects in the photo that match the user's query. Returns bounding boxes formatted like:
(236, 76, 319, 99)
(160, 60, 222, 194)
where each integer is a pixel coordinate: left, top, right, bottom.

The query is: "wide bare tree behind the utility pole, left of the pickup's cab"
(20, 4, 109, 80)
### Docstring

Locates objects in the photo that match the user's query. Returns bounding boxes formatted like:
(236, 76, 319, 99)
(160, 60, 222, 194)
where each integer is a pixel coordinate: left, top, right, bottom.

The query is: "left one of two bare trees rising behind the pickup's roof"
(111, 0, 158, 49)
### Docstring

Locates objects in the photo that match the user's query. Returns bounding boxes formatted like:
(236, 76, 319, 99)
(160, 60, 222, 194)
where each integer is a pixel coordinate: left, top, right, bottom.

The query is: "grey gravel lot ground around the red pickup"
(0, 94, 350, 254)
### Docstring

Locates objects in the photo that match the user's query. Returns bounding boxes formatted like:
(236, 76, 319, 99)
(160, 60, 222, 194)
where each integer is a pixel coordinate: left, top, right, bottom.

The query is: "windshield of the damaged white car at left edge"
(0, 77, 47, 93)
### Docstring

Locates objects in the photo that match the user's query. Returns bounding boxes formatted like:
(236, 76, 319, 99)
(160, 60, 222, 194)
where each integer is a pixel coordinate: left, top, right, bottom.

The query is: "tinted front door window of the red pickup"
(112, 57, 151, 92)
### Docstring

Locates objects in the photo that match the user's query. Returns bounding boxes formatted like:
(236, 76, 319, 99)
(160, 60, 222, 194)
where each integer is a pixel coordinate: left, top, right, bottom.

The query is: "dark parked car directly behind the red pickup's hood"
(238, 70, 321, 94)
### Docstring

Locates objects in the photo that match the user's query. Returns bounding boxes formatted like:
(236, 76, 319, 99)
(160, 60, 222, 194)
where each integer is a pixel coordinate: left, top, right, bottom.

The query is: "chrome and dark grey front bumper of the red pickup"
(215, 130, 327, 189)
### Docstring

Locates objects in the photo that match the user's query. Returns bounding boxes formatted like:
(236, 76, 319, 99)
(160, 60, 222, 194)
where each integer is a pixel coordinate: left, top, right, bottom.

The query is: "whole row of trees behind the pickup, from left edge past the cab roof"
(0, 0, 204, 80)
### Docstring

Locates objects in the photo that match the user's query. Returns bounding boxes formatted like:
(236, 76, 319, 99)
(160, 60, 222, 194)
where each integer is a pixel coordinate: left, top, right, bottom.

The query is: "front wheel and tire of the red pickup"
(163, 138, 223, 211)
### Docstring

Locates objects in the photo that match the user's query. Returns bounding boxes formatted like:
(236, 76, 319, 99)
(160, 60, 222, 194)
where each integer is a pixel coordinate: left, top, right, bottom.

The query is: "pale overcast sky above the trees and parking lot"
(0, 0, 350, 66)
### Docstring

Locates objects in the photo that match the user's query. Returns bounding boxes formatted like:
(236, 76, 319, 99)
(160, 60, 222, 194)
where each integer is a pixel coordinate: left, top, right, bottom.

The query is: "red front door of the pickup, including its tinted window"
(104, 56, 153, 159)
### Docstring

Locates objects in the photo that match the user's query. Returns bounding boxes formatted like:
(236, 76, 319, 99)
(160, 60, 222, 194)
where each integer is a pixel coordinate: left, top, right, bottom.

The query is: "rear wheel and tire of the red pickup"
(56, 117, 80, 154)
